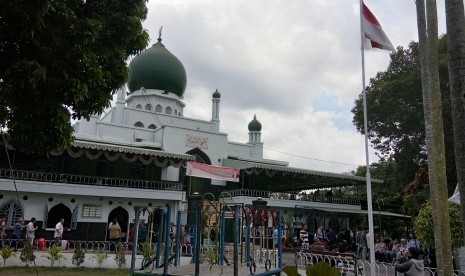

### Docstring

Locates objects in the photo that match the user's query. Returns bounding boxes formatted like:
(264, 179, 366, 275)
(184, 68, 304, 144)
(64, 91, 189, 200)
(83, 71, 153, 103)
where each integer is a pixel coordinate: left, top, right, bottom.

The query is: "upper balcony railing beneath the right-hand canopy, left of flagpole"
(228, 189, 360, 205)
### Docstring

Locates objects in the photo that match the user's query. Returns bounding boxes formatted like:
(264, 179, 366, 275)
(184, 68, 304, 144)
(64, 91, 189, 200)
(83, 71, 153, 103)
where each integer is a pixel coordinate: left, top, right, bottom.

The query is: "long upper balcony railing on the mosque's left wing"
(0, 169, 183, 191)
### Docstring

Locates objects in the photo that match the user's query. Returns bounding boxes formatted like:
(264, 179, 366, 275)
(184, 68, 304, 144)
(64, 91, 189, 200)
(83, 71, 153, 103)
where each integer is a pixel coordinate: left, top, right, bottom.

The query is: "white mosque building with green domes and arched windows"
(0, 33, 381, 243)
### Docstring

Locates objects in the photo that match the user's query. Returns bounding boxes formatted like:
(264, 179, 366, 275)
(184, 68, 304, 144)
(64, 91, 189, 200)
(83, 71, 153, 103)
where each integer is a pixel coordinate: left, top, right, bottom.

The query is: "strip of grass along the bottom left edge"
(0, 267, 129, 276)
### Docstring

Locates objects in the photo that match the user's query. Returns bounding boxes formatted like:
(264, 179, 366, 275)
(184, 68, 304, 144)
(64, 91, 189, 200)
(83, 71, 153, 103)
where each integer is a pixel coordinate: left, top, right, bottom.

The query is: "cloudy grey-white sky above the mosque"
(140, 0, 445, 172)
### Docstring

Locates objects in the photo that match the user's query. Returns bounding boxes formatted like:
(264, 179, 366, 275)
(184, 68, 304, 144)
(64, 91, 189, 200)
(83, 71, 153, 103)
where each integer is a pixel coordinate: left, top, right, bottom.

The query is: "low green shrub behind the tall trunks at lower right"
(413, 202, 464, 249)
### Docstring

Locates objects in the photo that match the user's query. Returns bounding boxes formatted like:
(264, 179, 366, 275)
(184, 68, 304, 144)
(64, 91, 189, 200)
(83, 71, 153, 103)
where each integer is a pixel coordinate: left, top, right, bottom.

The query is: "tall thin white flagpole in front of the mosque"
(360, 0, 376, 276)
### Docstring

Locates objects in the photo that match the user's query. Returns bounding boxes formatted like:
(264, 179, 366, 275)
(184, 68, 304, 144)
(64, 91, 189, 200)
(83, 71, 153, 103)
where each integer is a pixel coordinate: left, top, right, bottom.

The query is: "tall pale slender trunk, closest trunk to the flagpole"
(416, 0, 453, 275)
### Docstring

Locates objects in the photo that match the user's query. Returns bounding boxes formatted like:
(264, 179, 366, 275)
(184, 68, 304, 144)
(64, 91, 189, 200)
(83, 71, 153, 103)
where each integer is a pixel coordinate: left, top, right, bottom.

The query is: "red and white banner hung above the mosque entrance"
(186, 162, 239, 182)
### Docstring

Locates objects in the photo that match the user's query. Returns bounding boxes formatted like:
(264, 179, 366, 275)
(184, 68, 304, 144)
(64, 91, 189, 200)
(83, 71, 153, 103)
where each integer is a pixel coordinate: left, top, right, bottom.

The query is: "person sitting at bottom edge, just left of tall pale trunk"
(394, 247, 425, 276)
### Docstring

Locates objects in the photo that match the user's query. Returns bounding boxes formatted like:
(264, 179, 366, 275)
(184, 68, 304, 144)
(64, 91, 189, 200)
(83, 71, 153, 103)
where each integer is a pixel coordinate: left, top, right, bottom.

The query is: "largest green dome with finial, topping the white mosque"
(128, 38, 187, 97)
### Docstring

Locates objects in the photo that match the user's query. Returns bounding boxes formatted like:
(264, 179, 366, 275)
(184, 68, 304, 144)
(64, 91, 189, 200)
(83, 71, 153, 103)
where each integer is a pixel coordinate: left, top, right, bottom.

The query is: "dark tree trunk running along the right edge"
(446, 0, 465, 245)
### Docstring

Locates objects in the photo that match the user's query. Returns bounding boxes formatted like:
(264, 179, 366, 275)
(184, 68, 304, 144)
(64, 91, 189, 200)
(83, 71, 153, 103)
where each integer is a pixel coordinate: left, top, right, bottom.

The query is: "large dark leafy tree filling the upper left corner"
(0, 0, 148, 153)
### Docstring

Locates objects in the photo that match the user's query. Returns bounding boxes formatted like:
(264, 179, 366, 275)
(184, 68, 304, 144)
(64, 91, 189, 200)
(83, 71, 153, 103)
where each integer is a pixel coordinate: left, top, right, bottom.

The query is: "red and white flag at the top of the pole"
(362, 2, 395, 51)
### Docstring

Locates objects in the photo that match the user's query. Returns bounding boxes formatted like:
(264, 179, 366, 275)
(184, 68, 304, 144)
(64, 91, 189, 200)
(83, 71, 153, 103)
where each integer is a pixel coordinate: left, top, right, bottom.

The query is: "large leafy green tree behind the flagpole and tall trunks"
(352, 36, 456, 215)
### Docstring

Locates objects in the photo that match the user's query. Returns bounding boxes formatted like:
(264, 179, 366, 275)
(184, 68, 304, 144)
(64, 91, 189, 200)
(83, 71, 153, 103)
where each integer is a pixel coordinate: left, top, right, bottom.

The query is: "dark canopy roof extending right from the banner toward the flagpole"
(223, 159, 383, 192)
